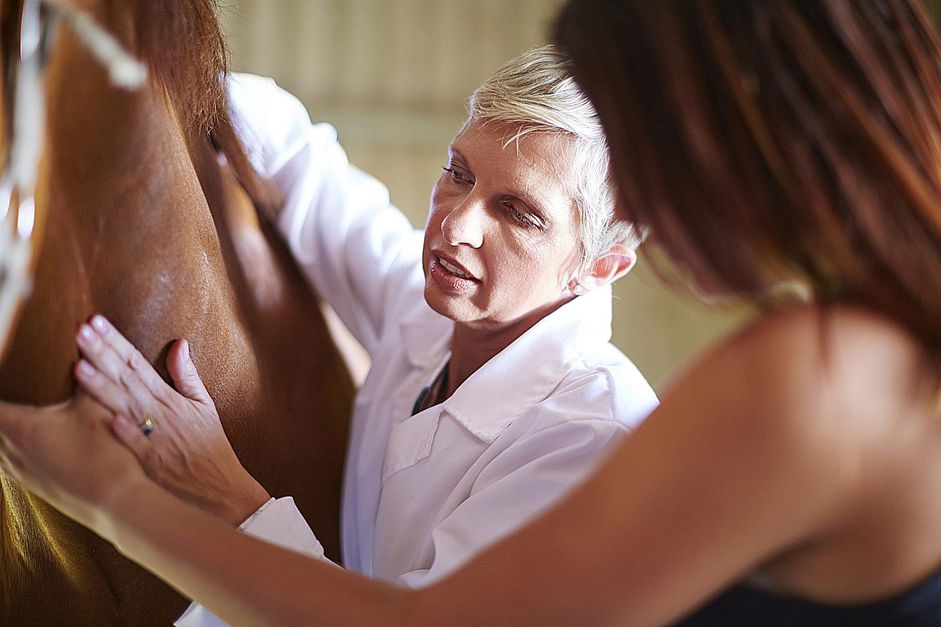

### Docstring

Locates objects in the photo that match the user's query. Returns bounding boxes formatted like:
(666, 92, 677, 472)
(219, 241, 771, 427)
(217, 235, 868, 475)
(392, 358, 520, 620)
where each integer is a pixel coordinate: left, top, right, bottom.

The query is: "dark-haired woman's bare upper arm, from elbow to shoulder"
(412, 316, 865, 626)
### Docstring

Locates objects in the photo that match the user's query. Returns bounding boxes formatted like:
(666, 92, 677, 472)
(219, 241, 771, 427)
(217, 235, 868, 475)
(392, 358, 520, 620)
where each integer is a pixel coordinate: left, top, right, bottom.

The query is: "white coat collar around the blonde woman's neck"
(402, 286, 611, 444)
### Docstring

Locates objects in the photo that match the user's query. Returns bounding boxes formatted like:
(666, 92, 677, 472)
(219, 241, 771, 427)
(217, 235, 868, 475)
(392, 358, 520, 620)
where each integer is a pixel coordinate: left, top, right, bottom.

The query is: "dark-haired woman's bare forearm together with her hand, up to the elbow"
(0, 395, 408, 625)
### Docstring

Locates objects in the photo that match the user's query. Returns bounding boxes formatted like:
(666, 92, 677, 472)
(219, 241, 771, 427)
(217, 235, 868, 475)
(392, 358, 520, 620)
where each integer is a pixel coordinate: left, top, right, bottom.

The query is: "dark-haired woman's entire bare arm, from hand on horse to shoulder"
(0, 308, 858, 627)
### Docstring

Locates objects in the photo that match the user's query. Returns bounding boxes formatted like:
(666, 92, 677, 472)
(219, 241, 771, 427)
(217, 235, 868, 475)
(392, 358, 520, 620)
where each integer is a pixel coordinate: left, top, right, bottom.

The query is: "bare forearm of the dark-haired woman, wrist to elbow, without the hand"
(104, 482, 404, 625)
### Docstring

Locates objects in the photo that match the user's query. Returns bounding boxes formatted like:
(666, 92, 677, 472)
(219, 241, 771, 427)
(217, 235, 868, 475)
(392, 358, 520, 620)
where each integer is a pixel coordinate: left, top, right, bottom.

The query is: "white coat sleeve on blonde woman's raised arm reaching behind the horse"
(229, 75, 421, 352)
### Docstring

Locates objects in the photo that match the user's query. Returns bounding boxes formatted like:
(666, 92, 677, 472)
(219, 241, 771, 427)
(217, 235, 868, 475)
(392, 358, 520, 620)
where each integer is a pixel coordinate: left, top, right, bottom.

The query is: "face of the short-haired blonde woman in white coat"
(423, 122, 579, 331)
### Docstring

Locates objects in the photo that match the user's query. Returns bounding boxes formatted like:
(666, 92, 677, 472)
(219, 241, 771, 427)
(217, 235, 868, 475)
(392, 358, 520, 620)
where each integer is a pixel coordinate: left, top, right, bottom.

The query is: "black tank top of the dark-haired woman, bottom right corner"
(676, 572, 941, 627)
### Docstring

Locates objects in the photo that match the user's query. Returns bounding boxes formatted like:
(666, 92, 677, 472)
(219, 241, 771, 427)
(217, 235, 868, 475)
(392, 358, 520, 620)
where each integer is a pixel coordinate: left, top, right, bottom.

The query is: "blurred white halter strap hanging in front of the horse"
(0, 0, 147, 357)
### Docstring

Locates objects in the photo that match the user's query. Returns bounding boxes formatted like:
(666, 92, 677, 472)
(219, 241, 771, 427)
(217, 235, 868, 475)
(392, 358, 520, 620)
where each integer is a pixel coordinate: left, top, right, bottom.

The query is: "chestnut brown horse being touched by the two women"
(0, 0, 352, 626)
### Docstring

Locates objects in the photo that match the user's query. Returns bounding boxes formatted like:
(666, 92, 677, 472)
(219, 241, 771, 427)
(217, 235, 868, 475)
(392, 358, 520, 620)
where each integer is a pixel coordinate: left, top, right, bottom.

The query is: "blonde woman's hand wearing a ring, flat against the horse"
(75, 316, 269, 525)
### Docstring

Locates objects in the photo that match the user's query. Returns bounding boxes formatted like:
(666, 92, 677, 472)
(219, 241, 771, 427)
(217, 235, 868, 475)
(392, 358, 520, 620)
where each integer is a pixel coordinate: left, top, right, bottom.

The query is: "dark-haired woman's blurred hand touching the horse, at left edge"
(0, 392, 150, 529)
